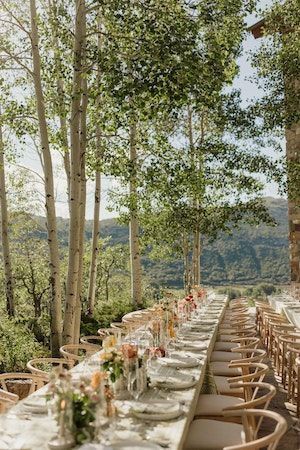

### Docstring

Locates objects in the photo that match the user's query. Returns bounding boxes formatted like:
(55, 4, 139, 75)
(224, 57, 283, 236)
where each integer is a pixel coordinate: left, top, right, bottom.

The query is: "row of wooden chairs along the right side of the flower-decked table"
(185, 299, 287, 450)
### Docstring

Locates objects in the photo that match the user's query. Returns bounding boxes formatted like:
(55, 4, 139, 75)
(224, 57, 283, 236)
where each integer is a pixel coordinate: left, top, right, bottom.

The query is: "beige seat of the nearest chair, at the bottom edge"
(184, 419, 245, 450)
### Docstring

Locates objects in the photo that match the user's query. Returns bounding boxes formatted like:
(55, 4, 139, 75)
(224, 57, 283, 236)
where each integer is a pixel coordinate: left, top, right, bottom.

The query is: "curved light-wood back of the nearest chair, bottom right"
(223, 409, 287, 450)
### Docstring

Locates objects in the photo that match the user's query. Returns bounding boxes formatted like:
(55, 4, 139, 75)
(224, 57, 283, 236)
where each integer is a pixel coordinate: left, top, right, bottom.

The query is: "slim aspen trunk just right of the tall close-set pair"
(88, 15, 102, 317)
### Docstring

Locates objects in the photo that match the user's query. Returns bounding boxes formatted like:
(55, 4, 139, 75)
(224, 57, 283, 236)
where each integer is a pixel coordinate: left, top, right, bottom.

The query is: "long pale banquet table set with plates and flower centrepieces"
(0, 294, 228, 450)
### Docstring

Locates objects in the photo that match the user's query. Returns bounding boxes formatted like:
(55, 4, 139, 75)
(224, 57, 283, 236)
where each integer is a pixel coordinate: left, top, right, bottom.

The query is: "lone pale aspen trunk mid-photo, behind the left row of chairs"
(129, 123, 142, 307)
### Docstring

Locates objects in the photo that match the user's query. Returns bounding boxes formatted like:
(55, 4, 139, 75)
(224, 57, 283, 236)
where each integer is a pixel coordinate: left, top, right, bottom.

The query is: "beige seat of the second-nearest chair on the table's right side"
(195, 394, 244, 416)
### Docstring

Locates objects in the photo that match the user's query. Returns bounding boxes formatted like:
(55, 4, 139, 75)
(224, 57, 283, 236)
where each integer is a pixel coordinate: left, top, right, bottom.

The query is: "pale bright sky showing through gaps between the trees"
(19, 0, 279, 219)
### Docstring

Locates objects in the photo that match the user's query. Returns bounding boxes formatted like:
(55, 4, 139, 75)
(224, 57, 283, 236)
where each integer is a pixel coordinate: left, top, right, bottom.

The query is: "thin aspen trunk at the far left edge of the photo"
(0, 115, 15, 317)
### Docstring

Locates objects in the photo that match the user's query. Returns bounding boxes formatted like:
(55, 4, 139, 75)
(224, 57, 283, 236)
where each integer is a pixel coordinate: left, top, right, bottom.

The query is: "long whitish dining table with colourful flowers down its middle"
(0, 292, 228, 450)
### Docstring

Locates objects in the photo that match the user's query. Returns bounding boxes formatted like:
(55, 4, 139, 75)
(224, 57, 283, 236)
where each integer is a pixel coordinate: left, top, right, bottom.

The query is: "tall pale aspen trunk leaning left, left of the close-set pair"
(30, 0, 62, 356)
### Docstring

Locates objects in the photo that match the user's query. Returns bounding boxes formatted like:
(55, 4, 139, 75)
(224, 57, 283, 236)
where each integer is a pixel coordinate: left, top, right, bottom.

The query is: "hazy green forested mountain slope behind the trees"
(35, 197, 289, 288)
